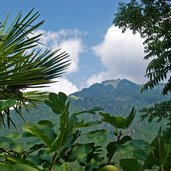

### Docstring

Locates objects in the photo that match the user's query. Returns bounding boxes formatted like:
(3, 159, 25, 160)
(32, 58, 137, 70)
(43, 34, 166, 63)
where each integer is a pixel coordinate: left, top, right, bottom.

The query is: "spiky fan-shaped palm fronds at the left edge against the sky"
(0, 10, 70, 127)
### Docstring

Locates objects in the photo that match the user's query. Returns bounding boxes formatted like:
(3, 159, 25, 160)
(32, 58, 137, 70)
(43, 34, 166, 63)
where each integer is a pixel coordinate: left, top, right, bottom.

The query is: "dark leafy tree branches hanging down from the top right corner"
(113, 0, 171, 94)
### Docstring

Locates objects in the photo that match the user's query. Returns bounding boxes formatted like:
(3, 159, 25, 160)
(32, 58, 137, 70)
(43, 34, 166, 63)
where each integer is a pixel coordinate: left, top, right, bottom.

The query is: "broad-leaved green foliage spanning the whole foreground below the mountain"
(0, 92, 171, 171)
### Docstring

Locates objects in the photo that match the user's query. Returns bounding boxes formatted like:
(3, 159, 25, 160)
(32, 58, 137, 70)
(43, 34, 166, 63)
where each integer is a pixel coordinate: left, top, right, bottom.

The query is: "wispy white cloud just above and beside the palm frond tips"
(35, 29, 84, 73)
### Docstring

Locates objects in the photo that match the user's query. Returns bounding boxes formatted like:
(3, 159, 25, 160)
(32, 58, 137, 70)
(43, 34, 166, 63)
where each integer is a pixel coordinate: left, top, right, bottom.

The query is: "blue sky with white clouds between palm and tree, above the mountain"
(0, 0, 147, 94)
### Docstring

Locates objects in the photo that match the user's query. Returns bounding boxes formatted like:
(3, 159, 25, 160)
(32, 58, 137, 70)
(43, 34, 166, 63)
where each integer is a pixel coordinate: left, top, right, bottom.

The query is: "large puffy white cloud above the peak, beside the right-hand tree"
(87, 26, 147, 85)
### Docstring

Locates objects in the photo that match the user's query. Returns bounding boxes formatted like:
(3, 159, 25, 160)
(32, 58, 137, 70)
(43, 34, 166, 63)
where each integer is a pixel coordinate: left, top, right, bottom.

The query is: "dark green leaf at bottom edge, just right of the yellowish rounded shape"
(120, 159, 144, 171)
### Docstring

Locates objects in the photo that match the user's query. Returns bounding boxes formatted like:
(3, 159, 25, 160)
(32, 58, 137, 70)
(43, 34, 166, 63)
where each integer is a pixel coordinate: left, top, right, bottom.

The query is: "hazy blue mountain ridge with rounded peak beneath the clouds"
(70, 79, 169, 115)
